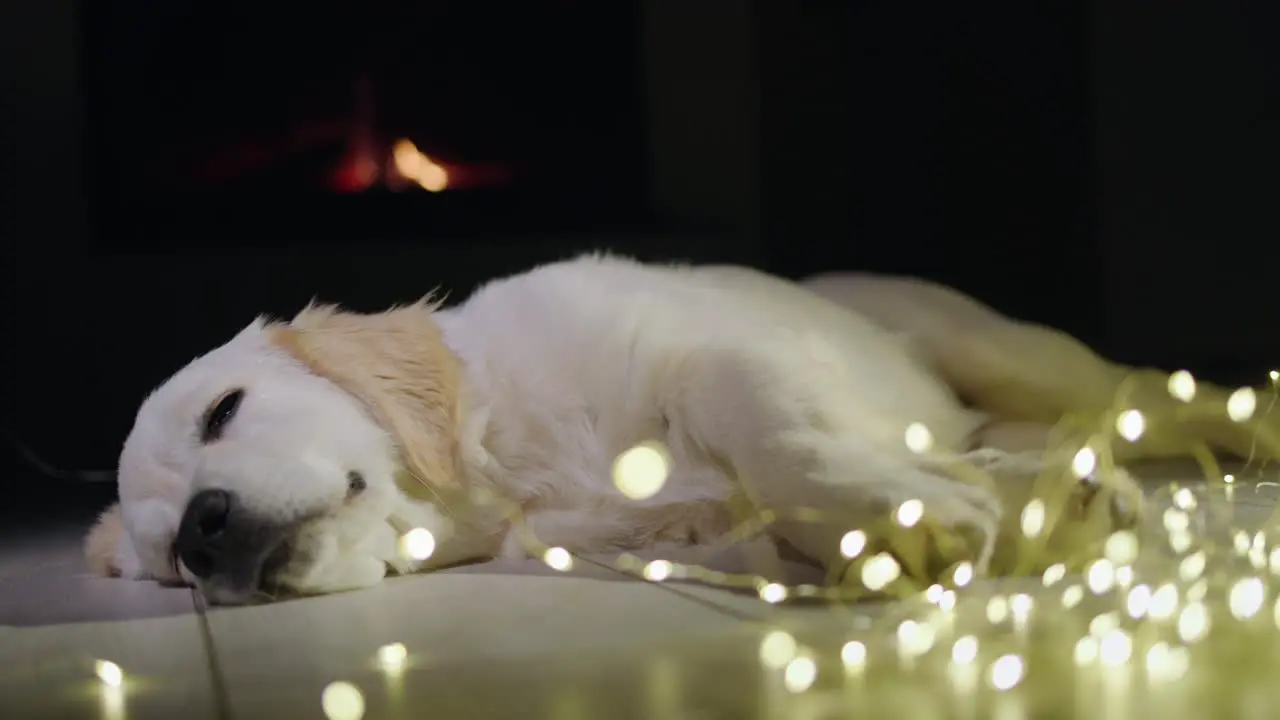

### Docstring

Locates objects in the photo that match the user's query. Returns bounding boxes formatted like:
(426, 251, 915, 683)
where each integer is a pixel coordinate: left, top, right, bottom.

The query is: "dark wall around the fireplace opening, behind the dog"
(0, 0, 1280, 517)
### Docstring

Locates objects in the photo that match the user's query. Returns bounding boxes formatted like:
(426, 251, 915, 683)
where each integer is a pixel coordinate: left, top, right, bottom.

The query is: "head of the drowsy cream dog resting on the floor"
(87, 299, 496, 603)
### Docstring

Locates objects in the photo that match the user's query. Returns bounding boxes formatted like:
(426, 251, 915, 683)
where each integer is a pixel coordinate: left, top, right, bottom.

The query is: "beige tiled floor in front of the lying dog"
(0, 458, 1275, 720)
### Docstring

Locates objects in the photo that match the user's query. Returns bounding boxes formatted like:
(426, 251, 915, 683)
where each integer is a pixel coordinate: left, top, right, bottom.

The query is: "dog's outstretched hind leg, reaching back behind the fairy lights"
(803, 273, 1280, 460)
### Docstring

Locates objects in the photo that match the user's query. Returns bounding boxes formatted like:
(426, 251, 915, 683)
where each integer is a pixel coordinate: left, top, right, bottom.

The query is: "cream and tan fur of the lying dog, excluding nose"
(87, 256, 1228, 602)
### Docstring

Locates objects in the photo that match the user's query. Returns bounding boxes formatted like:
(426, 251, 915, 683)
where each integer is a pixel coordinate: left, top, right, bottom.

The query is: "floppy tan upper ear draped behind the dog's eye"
(268, 300, 461, 500)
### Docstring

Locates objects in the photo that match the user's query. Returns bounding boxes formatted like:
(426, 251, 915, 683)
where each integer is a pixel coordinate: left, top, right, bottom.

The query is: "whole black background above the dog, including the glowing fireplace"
(0, 0, 1280, 533)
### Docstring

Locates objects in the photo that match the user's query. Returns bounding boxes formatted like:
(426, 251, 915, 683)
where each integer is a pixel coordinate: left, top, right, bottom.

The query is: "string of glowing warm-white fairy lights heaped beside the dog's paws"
(87, 370, 1280, 720)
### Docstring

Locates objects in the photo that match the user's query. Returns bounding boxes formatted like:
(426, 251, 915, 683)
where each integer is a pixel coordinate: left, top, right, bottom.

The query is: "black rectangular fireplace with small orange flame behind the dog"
(84, 0, 646, 247)
